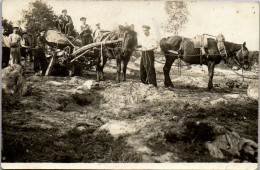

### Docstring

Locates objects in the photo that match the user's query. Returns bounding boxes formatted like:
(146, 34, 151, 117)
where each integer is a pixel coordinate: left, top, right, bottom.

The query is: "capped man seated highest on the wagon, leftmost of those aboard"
(57, 9, 74, 35)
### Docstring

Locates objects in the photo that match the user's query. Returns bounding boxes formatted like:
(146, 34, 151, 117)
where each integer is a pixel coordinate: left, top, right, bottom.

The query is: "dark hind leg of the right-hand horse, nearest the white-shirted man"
(163, 56, 175, 87)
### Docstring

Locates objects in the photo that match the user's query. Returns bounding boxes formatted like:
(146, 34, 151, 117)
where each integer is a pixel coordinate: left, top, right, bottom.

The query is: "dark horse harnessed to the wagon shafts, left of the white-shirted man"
(96, 26, 137, 83)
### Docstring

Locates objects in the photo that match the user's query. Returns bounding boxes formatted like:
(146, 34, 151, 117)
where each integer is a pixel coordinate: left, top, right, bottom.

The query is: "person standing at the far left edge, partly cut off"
(2, 28, 10, 69)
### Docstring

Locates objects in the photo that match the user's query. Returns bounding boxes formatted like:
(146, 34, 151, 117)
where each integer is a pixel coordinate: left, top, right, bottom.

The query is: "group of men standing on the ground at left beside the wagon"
(2, 26, 50, 75)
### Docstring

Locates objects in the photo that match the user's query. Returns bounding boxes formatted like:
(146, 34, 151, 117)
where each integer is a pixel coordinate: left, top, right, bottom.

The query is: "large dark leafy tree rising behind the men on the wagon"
(22, 0, 57, 33)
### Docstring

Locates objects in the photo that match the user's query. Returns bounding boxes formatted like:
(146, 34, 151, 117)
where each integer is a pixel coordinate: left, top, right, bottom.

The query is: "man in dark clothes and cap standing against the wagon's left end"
(34, 29, 51, 76)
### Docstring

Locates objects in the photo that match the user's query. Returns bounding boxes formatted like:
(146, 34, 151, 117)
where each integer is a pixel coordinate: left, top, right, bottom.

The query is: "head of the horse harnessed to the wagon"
(119, 25, 137, 55)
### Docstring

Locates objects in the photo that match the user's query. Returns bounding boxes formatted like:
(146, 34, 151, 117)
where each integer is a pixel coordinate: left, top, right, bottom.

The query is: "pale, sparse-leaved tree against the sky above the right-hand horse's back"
(163, 1, 189, 35)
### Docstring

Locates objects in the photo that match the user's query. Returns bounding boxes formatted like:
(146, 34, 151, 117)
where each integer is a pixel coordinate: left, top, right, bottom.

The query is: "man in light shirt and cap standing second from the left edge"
(9, 27, 22, 65)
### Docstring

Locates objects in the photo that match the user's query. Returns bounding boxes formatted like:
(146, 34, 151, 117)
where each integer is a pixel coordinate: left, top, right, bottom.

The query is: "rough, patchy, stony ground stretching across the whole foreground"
(2, 54, 258, 163)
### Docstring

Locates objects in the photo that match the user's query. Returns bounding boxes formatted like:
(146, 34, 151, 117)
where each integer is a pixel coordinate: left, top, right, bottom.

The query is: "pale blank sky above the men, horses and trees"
(2, 0, 259, 50)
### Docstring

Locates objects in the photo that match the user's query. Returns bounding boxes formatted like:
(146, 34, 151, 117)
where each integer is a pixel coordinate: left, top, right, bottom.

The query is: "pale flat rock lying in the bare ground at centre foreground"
(99, 121, 137, 139)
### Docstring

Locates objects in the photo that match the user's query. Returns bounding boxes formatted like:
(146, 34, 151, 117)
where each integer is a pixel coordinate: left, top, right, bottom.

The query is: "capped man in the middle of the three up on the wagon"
(79, 17, 93, 45)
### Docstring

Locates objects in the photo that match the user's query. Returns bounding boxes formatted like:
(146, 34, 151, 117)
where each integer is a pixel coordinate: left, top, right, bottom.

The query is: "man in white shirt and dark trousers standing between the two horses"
(140, 25, 158, 87)
